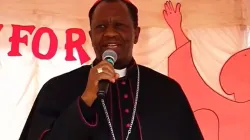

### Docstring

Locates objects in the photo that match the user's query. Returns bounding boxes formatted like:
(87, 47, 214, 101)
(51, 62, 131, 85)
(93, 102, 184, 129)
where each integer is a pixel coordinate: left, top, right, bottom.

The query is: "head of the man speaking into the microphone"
(89, 0, 140, 69)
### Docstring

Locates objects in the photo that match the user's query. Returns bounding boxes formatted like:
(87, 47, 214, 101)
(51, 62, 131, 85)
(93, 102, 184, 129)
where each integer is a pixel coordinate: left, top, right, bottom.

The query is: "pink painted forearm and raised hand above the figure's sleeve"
(163, 1, 190, 49)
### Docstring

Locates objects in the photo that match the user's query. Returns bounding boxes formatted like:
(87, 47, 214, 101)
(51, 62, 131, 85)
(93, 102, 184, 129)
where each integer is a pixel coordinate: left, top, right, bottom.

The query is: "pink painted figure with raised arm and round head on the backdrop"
(163, 1, 250, 140)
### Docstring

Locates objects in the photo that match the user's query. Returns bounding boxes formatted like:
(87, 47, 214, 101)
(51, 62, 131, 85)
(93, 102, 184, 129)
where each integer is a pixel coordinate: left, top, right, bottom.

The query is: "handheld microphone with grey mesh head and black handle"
(97, 50, 117, 99)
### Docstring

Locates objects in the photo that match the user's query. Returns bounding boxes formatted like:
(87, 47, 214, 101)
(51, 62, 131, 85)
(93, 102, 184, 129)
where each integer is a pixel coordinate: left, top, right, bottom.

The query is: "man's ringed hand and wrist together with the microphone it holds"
(81, 50, 119, 106)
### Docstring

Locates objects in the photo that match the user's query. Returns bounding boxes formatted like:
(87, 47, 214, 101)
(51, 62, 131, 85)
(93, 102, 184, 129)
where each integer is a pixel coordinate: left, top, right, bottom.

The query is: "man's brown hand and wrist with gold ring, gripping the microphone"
(81, 60, 119, 106)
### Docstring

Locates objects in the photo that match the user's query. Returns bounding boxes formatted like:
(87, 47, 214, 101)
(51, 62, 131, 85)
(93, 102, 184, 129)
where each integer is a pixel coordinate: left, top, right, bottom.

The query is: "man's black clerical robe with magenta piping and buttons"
(20, 59, 203, 140)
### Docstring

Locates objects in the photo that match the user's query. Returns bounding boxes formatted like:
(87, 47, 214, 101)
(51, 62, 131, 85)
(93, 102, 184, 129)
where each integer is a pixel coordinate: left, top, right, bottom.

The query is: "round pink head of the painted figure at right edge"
(220, 48, 250, 102)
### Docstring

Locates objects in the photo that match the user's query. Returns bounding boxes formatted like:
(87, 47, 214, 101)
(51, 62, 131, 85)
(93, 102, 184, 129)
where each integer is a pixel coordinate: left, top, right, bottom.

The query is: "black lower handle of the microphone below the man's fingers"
(97, 80, 109, 99)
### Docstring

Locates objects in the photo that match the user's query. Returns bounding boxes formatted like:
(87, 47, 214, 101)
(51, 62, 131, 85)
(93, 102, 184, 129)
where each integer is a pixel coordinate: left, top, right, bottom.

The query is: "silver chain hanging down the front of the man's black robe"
(92, 65, 140, 140)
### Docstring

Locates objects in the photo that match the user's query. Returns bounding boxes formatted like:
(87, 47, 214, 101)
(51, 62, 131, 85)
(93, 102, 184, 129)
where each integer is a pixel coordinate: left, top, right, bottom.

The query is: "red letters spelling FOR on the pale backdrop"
(0, 24, 90, 64)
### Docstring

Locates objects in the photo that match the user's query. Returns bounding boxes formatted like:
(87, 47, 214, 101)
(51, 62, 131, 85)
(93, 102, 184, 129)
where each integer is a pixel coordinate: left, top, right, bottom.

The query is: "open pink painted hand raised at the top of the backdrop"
(163, 1, 182, 30)
